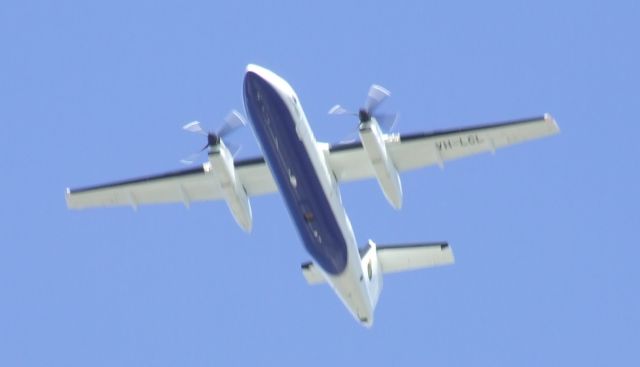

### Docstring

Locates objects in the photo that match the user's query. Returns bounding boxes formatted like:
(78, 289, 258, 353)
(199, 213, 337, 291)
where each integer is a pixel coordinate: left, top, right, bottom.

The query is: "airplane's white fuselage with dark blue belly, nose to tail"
(244, 65, 375, 326)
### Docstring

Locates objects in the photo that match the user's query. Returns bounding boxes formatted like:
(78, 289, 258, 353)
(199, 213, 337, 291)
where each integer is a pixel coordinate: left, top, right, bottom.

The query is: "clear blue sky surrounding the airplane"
(0, 1, 640, 366)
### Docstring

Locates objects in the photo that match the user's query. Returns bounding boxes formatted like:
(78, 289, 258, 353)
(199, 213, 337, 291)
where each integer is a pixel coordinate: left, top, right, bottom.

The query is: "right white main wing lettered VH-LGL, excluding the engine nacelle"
(328, 114, 559, 181)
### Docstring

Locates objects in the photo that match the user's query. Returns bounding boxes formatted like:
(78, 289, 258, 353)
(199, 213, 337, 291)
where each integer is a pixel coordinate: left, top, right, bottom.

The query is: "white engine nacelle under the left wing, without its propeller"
(208, 141, 253, 232)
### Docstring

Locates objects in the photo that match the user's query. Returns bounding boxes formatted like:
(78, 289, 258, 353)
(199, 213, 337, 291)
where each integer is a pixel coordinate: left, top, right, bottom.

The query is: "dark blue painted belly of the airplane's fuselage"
(244, 72, 347, 275)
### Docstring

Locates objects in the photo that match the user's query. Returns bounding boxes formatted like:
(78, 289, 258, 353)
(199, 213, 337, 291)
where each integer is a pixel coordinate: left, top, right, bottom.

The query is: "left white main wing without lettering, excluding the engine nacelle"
(66, 158, 277, 209)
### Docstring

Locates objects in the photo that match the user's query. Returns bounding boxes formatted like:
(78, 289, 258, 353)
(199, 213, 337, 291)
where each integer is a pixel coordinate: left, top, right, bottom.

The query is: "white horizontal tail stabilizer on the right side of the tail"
(377, 242, 454, 274)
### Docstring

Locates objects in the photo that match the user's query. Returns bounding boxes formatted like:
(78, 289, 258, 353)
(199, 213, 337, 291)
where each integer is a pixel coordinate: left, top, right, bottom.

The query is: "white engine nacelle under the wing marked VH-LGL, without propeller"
(359, 117, 402, 209)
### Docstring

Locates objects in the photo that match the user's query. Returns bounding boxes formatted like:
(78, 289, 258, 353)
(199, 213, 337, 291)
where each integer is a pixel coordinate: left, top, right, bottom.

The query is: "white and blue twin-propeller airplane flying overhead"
(66, 64, 559, 327)
